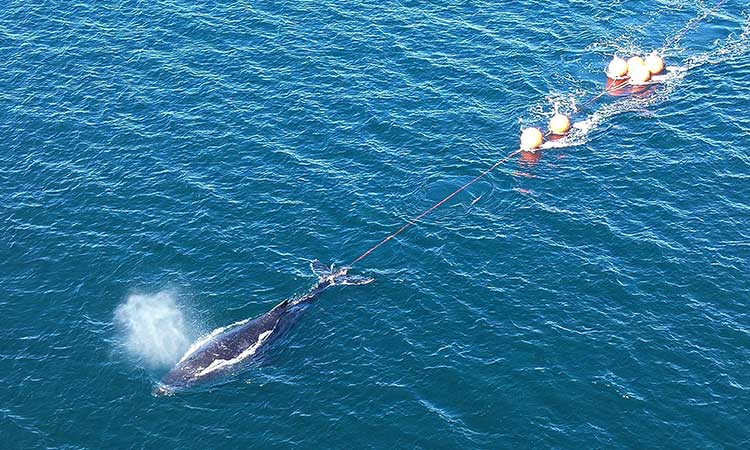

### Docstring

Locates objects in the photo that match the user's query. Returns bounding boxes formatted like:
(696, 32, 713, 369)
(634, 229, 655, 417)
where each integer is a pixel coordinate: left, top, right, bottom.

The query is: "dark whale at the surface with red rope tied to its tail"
(153, 260, 373, 396)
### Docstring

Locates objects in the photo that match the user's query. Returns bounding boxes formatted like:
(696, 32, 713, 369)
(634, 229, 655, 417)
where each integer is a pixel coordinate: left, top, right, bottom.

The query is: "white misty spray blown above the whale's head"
(115, 291, 195, 368)
